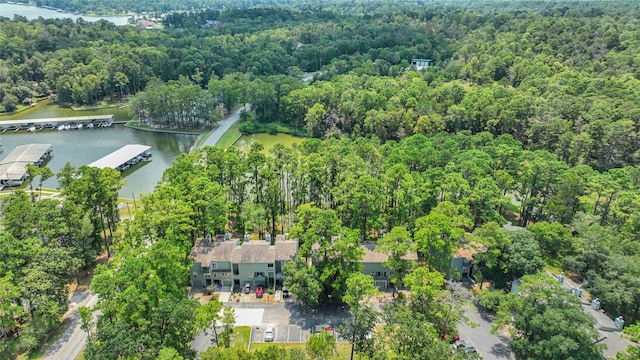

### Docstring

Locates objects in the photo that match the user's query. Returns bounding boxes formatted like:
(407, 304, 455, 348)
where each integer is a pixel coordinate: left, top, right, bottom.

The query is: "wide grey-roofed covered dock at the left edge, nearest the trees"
(0, 144, 53, 186)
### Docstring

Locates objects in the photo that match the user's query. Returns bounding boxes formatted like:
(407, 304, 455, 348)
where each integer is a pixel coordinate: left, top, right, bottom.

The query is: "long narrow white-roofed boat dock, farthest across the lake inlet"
(0, 114, 114, 132)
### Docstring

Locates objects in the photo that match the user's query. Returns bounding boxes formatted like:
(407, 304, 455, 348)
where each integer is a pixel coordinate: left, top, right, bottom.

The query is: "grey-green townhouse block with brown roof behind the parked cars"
(191, 235, 298, 288)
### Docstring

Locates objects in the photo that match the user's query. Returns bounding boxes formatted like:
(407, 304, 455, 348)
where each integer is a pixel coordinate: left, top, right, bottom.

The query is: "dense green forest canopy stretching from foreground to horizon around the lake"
(0, 0, 640, 359)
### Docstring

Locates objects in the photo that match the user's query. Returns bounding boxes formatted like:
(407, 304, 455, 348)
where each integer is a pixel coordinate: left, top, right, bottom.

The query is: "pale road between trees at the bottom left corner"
(44, 290, 98, 360)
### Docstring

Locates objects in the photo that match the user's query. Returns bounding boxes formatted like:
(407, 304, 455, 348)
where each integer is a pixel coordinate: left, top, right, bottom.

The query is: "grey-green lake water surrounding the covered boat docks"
(0, 101, 197, 198)
